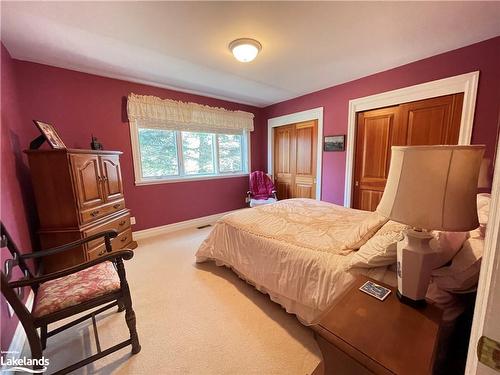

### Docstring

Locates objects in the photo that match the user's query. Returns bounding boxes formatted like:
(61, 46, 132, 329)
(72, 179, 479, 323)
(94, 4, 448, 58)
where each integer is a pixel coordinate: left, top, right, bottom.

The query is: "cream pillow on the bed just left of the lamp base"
(350, 221, 409, 268)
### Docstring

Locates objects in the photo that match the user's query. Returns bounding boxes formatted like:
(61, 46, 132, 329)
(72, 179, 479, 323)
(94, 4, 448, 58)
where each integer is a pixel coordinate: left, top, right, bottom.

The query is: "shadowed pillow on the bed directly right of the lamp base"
(432, 229, 484, 293)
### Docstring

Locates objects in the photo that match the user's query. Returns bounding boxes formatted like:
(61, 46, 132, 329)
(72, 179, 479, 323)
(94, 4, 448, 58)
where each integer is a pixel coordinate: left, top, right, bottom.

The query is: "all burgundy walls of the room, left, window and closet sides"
(0, 37, 500, 349)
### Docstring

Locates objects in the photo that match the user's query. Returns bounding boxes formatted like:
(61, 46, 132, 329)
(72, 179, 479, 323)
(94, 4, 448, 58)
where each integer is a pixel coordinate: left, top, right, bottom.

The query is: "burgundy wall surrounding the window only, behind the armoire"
(10, 61, 265, 234)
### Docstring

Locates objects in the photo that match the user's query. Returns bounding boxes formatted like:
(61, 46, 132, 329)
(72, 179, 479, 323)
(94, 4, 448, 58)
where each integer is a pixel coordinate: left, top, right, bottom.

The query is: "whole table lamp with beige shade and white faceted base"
(376, 145, 484, 306)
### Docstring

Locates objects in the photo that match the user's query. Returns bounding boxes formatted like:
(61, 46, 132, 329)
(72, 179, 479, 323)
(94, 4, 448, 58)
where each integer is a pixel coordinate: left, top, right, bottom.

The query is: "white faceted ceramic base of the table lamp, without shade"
(397, 229, 437, 306)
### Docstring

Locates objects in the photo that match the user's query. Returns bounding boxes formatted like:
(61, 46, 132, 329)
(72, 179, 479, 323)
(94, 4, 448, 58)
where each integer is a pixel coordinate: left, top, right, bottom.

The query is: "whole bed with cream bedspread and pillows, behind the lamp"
(196, 194, 491, 326)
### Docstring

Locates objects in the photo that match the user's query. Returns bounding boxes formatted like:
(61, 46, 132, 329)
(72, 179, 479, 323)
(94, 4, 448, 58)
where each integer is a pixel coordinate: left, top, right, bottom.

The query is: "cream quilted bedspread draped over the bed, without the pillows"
(196, 199, 386, 324)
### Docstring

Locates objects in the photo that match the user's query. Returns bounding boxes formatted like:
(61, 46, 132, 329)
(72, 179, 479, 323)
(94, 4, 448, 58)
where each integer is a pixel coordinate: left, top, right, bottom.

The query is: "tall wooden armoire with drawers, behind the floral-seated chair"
(25, 149, 137, 273)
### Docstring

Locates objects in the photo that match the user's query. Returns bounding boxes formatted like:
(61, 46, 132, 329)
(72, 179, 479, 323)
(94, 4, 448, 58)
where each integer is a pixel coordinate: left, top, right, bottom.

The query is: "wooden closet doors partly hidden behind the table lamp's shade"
(352, 93, 463, 211)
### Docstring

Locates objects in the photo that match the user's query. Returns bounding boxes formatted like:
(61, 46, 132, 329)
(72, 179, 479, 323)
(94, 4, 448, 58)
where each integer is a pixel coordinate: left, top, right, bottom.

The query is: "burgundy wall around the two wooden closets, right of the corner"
(264, 37, 500, 204)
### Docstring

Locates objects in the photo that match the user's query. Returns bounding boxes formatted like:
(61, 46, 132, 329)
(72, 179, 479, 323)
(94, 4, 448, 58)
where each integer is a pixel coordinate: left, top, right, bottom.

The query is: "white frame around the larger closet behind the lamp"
(344, 71, 479, 207)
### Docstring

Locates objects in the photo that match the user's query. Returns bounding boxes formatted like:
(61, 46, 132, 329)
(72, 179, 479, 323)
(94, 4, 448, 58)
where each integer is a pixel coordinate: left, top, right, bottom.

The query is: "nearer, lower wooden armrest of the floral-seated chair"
(9, 249, 134, 288)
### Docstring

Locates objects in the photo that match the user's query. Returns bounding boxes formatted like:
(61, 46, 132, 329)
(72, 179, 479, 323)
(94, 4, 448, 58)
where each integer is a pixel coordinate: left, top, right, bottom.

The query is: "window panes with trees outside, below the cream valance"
(134, 124, 249, 184)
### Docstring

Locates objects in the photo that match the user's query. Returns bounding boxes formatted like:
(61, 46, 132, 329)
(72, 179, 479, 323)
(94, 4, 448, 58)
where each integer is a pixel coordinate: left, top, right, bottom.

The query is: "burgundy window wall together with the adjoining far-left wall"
(1, 44, 266, 350)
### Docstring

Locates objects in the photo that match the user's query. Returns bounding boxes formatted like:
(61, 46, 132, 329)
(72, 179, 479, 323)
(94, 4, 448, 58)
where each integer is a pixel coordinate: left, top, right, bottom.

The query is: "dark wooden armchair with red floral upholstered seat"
(0, 222, 141, 374)
